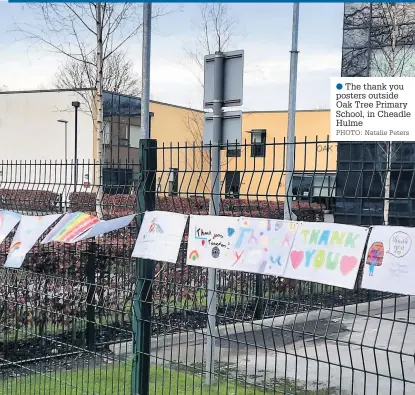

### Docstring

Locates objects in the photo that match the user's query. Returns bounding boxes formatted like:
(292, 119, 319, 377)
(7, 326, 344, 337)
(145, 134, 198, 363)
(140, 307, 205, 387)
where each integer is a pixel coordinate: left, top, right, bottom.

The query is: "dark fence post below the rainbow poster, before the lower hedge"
(85, 239, 97, 351)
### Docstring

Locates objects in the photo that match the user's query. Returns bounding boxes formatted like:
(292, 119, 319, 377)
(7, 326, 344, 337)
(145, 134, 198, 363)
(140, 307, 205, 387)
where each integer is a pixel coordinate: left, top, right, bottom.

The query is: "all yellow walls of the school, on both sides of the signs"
(150, 102, 337, 198)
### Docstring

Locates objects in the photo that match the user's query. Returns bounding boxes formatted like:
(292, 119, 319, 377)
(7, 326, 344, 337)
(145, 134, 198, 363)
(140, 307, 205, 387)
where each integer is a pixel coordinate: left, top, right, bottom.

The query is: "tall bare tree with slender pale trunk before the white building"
(17, 3, 163, 218)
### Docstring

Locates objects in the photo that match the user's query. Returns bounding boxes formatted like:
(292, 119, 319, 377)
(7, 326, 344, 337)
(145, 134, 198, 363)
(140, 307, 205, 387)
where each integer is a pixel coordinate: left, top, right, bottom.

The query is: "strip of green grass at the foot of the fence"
(0, 362, 338, 395)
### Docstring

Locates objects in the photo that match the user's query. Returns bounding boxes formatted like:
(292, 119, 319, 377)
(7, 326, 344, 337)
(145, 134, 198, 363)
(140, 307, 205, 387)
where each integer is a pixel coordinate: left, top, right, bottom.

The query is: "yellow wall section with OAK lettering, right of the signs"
(235, 110, 337, 198)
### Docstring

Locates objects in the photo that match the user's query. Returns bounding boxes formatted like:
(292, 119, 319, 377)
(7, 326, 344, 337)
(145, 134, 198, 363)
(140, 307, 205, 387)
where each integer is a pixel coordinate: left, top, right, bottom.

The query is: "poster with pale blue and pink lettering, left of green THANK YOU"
(232, 217, 298, 276)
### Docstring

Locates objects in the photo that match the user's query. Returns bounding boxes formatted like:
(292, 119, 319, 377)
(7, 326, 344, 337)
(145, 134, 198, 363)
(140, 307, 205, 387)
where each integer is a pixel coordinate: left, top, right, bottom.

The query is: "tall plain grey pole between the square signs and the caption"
(284, 3, 300, 220)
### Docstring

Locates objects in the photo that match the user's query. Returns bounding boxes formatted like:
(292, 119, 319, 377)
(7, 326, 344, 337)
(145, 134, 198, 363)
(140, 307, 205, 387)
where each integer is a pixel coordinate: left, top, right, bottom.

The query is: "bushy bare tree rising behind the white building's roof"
(54, 49, 141, 116)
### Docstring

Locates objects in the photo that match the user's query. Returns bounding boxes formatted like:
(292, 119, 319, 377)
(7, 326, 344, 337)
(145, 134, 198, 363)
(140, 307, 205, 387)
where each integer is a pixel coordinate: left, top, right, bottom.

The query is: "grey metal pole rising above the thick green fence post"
(141, 3, 151, 139)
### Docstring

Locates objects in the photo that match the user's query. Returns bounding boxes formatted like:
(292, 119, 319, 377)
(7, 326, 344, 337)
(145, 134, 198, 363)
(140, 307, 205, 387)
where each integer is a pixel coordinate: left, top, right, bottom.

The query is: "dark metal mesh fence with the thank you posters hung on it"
(0, 141, 415, 395)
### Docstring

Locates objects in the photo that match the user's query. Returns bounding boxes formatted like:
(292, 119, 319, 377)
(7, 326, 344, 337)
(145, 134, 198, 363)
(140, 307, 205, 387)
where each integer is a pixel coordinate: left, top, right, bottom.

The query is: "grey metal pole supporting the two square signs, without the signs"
(206, 52, 224, 385)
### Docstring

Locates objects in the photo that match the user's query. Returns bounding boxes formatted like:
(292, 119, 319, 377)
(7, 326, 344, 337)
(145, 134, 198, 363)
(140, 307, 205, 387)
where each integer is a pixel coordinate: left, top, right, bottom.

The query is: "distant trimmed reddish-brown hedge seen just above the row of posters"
(0, 189, 324, 222)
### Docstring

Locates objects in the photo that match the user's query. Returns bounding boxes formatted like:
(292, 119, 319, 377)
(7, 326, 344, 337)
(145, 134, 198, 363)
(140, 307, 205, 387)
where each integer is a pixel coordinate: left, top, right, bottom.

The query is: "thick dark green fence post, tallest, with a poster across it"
(131, 139, 157, 395)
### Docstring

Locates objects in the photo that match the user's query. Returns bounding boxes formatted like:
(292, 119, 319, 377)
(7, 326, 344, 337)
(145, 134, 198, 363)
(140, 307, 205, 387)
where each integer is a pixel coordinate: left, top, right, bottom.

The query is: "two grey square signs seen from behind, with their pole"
(203, 51, 244, 385)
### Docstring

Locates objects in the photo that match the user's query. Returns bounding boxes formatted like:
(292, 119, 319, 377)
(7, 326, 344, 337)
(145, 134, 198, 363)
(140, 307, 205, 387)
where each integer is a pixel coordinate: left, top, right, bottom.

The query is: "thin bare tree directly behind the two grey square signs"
(184, 3, 242, 190)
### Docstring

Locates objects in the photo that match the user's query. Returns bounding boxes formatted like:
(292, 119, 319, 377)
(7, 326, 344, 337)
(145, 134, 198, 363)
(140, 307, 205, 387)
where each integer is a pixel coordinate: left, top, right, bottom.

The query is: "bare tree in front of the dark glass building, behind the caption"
(369, 3, 415, 225)
